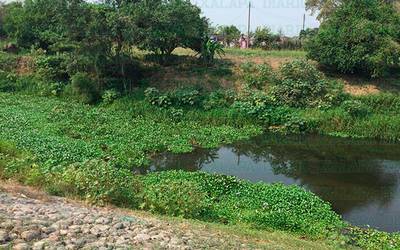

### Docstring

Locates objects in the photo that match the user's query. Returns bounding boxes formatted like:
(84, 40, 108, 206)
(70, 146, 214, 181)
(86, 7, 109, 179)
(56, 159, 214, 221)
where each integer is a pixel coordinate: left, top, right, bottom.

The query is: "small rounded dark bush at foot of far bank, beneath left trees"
(71, 73, 99, 104)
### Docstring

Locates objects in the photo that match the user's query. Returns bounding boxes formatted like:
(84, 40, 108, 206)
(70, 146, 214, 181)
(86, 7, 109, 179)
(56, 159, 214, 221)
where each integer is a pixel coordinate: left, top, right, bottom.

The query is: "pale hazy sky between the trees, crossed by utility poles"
(191, 0, 319, 36)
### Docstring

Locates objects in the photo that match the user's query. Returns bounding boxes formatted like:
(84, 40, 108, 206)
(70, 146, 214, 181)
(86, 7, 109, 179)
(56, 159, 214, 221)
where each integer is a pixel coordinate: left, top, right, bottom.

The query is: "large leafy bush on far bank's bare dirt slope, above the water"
(270, 60, 344, 108)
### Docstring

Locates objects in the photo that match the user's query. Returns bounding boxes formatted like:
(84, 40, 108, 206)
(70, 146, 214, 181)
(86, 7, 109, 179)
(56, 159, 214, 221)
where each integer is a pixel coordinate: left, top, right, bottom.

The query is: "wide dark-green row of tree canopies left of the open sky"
(0, 0, 208, 95)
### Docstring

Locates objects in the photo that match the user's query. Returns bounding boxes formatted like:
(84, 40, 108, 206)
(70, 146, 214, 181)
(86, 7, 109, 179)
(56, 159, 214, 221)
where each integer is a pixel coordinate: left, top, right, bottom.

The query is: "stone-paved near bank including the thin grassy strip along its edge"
(0, 182, 334, 250)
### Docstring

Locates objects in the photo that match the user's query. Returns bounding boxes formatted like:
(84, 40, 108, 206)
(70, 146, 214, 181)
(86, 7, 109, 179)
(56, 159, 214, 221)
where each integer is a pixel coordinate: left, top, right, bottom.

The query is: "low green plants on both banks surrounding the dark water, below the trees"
(0, 48, 400, 249)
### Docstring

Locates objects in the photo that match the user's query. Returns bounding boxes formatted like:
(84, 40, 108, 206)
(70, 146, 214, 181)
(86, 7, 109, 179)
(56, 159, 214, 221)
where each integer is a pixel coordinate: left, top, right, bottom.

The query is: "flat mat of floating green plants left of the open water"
(0, 93, 261, 168)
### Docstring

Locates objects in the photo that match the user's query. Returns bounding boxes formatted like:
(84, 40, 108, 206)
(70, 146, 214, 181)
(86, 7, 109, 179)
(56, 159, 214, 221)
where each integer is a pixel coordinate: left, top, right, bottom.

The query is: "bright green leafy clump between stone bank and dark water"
(142, 171, 343, 237)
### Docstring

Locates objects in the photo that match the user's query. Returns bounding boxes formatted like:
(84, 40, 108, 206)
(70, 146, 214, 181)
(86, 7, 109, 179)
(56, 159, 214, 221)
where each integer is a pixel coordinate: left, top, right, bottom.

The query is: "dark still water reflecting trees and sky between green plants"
(142, 135, 400, 232)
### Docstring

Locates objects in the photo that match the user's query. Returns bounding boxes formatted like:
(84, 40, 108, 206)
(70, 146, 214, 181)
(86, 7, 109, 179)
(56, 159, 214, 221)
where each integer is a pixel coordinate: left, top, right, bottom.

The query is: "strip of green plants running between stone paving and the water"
(0, 143, 400, 249)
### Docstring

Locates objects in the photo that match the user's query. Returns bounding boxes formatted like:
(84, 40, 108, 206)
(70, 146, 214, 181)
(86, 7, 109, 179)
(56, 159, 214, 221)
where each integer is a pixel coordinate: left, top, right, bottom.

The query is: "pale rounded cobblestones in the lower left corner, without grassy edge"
(0, 185, 252, 250)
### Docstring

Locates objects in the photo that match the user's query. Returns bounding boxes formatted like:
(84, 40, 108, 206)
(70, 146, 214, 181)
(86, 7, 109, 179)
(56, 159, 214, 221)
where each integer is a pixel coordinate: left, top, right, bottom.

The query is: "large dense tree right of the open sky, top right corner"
(306, 0, 400, 77)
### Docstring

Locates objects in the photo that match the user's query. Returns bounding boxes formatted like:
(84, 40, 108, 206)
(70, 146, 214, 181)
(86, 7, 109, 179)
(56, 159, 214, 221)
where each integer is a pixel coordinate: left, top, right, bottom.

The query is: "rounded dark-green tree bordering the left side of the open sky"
(134, 0, 208, 59)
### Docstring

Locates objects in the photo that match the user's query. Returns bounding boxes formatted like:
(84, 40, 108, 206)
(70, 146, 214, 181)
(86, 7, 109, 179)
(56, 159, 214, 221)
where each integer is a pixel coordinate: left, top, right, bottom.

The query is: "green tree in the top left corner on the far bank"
(4, 0, 86, 50)
